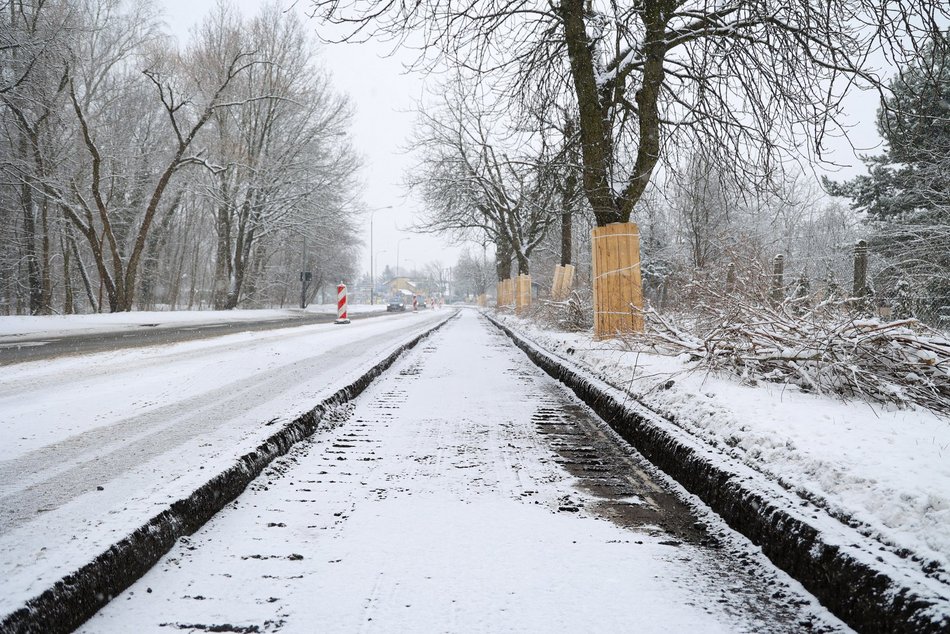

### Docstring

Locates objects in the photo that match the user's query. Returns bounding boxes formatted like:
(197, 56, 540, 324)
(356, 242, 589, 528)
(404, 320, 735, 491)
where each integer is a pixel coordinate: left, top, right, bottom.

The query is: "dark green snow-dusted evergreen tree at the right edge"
(825, 31, 950, 327)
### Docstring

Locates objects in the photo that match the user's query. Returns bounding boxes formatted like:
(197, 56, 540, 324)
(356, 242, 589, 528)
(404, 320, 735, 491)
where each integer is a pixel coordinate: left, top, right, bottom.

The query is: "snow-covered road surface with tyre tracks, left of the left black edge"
(0, 310, 450, 614)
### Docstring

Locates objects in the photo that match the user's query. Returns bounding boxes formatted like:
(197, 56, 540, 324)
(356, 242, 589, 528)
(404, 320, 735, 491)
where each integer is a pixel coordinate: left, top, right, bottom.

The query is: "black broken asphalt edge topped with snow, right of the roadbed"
(482, 313, 950, 634)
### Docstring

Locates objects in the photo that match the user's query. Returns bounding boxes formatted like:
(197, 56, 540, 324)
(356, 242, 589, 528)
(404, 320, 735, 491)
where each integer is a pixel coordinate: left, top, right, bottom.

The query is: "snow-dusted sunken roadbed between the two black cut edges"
(76, 311, 845, 633)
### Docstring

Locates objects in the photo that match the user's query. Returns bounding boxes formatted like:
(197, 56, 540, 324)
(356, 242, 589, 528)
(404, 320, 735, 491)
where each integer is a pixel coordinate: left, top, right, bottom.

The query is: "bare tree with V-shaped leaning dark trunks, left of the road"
(20, 0, 270, 311)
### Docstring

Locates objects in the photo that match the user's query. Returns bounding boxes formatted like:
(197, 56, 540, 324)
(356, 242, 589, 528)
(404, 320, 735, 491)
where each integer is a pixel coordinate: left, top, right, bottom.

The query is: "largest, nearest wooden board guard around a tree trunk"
(591, 222, 644, 339)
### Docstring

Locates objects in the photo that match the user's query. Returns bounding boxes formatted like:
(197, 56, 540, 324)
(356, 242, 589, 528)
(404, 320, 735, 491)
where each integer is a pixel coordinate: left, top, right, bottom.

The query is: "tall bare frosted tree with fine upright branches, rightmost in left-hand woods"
(196, 4, 357, 309)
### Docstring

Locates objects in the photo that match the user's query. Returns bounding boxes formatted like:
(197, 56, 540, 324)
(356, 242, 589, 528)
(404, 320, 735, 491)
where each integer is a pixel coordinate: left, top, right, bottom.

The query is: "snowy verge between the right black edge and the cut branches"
(494, 316, 950, 584)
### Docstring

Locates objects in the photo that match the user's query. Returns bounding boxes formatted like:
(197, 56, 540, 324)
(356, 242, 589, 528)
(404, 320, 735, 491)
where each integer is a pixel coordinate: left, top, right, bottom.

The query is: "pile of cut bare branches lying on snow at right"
(633, 289, 950, 414)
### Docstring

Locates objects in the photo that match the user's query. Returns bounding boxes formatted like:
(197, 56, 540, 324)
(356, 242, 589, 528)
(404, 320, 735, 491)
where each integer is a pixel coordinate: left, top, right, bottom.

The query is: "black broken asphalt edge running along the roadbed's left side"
(0, 311, 459, 634)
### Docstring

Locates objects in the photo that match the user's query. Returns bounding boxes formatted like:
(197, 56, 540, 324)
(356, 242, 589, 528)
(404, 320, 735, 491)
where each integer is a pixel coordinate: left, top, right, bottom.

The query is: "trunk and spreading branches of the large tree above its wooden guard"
(311, 0, 950, 225)
